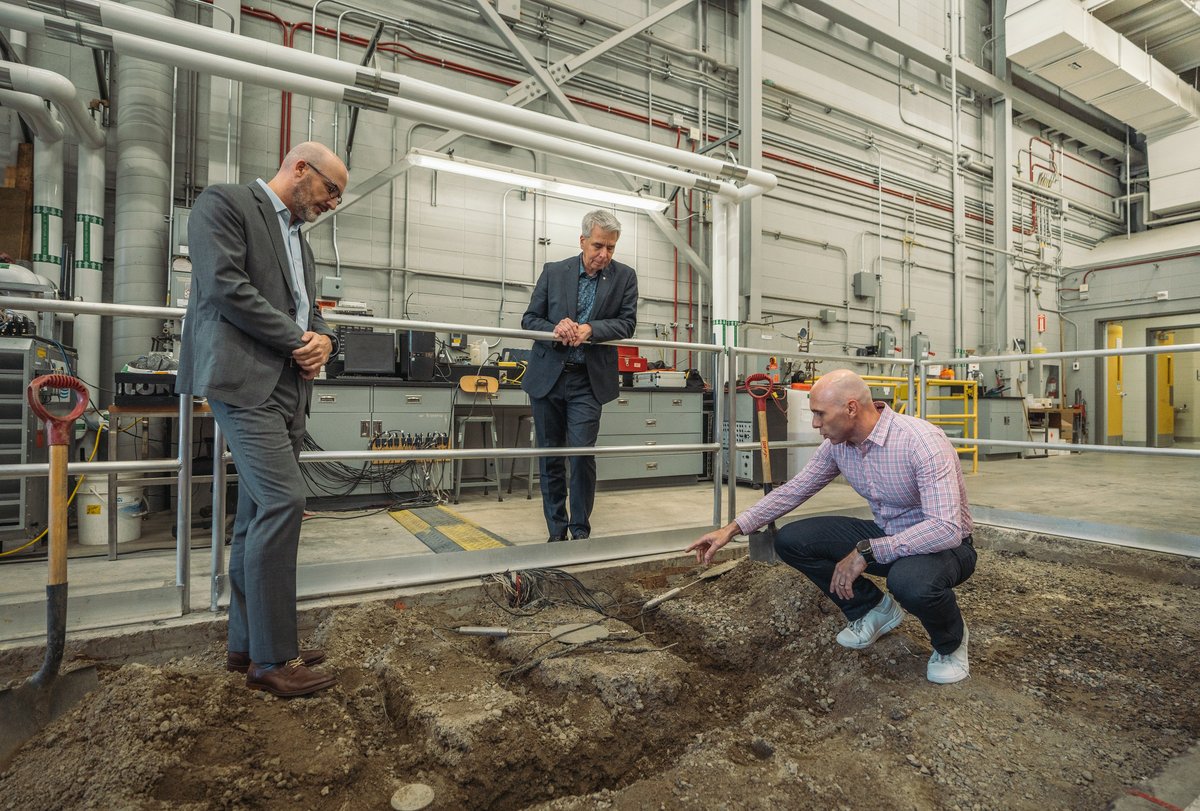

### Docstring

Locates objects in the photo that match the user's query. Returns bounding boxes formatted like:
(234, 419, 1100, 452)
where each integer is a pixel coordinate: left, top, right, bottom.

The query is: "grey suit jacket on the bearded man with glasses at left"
(175, 181, 336, 408)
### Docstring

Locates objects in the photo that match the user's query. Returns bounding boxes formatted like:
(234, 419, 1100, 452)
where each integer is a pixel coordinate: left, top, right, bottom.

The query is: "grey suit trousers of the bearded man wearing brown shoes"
(209, 366, 307, 665)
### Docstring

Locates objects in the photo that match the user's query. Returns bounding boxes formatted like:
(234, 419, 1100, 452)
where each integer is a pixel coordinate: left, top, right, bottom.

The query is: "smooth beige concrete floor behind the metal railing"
(0, 443, 1200, 647)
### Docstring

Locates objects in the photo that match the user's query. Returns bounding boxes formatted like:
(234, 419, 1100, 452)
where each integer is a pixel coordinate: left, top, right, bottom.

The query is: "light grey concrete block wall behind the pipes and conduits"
(0, 0, 1156, 376)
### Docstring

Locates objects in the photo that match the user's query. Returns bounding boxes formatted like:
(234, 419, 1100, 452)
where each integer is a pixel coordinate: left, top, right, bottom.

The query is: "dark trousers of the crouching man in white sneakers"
(775, 516, 976, 654)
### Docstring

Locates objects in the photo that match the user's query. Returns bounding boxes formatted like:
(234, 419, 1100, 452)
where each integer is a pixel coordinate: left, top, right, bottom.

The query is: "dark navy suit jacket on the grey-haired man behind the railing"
(521, 254, 637, 403)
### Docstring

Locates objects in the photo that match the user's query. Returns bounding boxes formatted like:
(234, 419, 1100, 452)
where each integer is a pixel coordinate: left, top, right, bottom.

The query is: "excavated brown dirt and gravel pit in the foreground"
(0, 531, 1200, 811)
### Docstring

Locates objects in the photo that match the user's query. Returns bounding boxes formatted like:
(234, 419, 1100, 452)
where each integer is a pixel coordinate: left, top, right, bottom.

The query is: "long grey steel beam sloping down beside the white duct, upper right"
(773, 0, 1126, 162)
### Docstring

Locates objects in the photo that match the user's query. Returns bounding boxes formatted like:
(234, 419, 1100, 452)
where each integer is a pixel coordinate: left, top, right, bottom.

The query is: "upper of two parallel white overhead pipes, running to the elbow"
(5, 0, 778, 197)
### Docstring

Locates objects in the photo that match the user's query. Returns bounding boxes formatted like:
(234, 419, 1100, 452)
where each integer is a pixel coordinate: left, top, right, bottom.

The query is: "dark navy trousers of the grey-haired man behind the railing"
(530, 368, 600, 537)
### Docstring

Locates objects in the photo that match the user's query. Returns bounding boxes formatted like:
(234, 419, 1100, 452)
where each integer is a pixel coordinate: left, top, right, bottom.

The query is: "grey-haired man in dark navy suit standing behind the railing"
(521, 209, 637, 541)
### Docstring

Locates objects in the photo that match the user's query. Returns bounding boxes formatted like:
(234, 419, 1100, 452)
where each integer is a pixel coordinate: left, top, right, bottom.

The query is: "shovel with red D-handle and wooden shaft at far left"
(0, 374, 97, 765)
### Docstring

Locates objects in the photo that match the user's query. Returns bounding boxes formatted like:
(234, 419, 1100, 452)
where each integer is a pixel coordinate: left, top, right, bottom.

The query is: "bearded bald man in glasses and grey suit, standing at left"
(178, 142, 348, 696)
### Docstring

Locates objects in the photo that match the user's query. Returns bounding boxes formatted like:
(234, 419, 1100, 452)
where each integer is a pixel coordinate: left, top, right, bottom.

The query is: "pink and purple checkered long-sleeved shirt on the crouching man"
(737, 403, 973, 563)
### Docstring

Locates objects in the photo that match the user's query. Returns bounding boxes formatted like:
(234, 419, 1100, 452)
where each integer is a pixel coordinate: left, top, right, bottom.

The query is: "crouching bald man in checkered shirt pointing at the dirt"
(688, 370, 976, 684)
